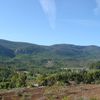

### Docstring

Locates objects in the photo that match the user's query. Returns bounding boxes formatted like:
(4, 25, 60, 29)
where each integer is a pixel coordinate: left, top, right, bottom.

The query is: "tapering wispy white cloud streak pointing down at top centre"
(39, 0, 56, 29)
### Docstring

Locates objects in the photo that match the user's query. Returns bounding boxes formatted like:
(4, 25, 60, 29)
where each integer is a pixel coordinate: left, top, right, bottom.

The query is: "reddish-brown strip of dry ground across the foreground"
(0, 85, 100, 100)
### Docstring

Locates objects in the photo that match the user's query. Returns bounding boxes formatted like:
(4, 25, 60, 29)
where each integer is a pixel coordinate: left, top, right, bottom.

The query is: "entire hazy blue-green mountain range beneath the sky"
(0, 39, 100, 67)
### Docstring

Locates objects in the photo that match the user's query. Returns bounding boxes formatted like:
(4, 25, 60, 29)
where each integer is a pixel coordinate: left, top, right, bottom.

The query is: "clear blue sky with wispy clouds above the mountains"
(0, 0, 100, 46)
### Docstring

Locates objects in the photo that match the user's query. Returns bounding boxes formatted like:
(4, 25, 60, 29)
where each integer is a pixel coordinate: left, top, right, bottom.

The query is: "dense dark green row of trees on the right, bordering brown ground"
(36, 70, 100, 86)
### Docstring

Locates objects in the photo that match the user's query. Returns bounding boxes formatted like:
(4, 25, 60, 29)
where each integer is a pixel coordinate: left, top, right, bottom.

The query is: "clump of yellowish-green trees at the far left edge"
(0, 68, 27, 89)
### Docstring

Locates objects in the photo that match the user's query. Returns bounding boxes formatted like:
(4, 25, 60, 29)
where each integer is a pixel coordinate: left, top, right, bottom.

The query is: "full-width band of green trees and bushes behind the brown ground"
(0, 68, 100, 89)
